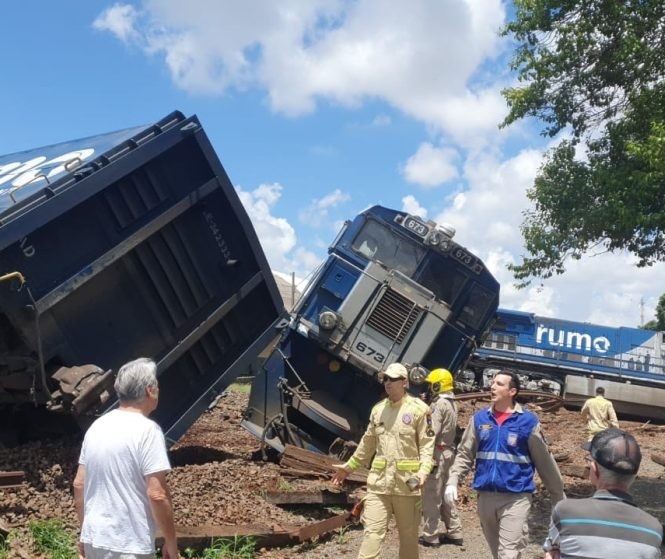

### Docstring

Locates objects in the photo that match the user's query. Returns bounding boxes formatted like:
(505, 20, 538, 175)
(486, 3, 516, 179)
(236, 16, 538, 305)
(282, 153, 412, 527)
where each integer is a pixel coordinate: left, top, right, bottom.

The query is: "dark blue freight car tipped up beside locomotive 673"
(0, 112, 283, 442)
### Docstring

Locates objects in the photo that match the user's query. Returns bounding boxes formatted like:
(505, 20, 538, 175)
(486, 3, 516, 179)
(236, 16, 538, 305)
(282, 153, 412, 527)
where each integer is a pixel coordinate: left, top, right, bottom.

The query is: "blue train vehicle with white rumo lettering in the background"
(470, 309, 665, 420)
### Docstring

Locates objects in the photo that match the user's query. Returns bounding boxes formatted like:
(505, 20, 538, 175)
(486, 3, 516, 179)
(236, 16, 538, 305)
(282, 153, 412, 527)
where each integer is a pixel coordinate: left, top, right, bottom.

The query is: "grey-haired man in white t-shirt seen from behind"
(74, 358, 178, 559)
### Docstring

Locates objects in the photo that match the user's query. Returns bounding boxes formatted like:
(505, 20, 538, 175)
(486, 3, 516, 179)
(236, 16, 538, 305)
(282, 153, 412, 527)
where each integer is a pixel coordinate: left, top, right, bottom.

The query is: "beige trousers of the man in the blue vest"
(478, 491, 533, 559)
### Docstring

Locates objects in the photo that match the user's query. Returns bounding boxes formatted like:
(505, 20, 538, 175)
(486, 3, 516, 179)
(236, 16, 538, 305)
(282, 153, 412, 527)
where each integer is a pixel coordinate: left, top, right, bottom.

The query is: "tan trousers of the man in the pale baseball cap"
(358, 493, 421, 559)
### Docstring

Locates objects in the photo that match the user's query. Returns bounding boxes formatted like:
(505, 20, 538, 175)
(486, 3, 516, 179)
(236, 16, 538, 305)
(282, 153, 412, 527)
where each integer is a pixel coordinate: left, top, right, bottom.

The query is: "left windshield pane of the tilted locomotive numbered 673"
(351, 219, 425, 277)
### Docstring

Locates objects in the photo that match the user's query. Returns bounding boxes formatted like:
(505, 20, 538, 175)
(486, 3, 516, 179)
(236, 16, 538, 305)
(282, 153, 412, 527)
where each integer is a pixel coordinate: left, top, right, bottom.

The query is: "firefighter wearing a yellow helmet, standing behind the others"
(418, 369, 464, 547)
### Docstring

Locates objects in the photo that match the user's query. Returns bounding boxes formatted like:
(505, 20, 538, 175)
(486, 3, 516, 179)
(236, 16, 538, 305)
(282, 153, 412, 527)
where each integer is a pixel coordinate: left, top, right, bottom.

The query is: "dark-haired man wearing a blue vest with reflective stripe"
(444, 371, 564, 559)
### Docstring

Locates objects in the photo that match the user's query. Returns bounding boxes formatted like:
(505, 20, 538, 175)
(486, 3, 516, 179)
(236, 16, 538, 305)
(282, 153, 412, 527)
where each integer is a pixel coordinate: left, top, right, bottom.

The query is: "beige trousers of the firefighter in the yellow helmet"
(423, 449, 463, 543)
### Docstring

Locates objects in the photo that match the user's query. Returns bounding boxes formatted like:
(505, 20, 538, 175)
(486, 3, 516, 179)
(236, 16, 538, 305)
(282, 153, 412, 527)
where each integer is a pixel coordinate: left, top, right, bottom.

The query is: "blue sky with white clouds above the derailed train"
(0, 0, 664, 326)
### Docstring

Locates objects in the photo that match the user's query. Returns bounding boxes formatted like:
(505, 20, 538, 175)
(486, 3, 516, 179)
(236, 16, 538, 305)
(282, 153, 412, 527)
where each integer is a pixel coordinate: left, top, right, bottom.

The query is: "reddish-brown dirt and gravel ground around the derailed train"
(0, 391, 665, 559)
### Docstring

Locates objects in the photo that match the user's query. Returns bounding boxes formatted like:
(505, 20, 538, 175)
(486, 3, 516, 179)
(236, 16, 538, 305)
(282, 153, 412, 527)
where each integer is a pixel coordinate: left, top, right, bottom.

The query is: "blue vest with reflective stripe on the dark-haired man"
(473, 408, 538, 493)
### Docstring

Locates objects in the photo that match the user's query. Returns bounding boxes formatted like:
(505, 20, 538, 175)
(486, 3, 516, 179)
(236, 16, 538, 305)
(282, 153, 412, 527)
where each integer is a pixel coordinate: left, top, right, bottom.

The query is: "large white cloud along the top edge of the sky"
(98, 0, 505, 147)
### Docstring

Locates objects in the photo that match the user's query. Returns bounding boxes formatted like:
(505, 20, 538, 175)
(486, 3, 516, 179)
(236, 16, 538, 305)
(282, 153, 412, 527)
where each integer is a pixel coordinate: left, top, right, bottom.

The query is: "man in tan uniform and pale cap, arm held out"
(333, 363, 434, 559)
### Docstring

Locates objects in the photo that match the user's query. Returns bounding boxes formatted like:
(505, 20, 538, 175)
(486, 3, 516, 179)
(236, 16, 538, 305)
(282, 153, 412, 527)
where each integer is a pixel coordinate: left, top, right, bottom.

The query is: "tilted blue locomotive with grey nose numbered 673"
(242, 206, 499, 456)
